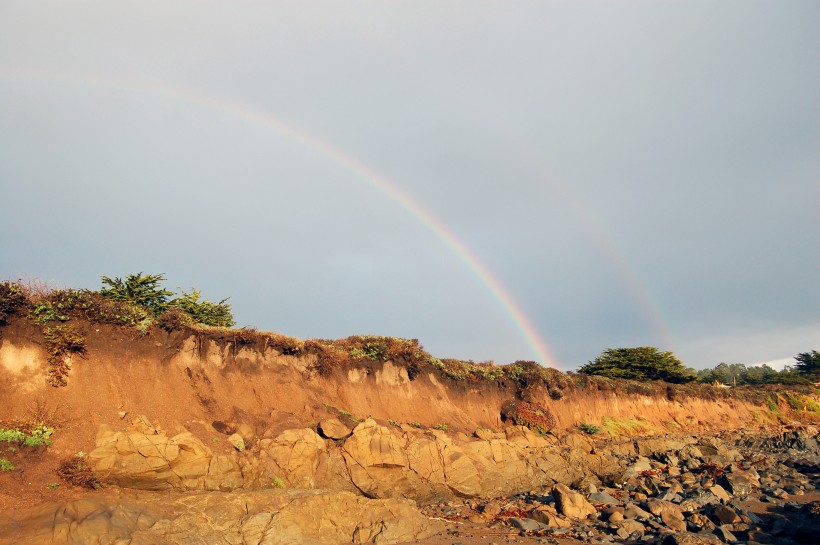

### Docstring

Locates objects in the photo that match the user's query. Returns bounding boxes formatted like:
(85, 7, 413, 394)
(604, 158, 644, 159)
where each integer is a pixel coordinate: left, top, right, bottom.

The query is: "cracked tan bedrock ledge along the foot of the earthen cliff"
(88, 419, 623, 499)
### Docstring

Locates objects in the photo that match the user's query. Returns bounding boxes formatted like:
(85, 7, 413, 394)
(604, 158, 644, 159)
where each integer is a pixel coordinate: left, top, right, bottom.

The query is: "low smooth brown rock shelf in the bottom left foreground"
(0, 491, 440, 545)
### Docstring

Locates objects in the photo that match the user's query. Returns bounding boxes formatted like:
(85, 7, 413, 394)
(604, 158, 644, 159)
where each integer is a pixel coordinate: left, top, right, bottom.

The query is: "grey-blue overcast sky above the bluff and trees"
(0, 0, 820, 370)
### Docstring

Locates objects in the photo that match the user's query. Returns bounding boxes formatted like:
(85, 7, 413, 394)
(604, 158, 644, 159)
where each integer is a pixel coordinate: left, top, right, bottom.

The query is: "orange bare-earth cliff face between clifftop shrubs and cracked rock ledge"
(0, 318, 784, 444)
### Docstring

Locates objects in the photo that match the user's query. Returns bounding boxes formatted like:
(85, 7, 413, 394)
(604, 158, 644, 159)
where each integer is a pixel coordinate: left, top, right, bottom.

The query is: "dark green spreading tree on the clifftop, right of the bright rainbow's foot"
(579, 346, 696, 383)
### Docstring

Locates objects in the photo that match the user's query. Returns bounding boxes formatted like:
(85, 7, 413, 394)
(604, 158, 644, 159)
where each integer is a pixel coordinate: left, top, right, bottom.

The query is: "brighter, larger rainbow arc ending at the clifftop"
(0, 76, 557, 367)
